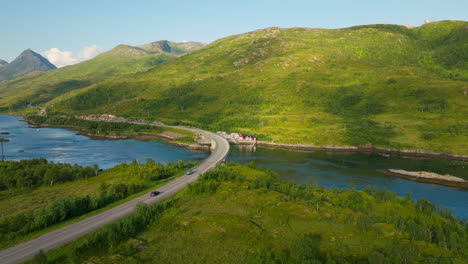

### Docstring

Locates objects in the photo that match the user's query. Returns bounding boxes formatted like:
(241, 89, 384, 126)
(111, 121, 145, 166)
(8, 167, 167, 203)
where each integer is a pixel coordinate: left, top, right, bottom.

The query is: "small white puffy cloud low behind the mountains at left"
(42, 45, 103, 68)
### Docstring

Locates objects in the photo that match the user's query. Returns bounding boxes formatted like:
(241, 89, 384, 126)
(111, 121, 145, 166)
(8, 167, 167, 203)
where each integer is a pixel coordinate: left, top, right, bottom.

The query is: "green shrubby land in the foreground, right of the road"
(33, 164, 468, 263)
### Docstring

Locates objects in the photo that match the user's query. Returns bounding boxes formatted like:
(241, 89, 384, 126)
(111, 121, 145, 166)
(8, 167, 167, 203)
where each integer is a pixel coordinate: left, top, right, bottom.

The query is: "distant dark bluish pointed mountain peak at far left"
(0, 49, 57, 82)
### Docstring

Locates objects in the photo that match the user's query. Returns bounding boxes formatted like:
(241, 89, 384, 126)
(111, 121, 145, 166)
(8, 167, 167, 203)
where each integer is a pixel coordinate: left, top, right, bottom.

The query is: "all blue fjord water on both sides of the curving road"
(0, 115, 468, 217)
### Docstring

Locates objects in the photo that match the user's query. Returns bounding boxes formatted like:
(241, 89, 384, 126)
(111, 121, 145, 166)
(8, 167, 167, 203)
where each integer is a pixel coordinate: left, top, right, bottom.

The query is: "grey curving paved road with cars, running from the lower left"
(0, 127, 229, 264)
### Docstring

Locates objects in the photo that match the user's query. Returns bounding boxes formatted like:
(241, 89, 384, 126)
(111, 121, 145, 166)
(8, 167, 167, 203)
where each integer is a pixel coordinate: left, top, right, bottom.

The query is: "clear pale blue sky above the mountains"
(0, 0, 468, 65)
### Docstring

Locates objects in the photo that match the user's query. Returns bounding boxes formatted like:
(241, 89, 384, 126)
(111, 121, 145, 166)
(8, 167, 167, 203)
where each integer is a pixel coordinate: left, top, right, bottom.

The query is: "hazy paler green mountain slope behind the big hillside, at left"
(0, 41, 203, 109)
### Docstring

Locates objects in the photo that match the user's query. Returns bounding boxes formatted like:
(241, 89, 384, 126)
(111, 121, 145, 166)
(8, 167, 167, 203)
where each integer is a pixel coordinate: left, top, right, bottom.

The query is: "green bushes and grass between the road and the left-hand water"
(0, 159, 194, 250)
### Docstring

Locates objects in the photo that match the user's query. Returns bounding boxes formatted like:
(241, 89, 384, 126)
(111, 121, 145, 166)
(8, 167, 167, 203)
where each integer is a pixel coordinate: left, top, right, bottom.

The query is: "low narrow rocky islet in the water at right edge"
(384, 169, 468, 188)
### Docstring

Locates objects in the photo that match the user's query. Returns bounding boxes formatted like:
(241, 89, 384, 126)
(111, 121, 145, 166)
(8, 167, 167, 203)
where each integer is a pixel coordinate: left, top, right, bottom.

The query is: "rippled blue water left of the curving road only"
(0, 115, 208, 169)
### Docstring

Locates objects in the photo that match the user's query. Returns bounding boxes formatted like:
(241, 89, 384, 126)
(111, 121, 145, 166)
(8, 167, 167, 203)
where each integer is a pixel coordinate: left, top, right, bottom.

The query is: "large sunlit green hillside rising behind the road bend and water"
(3, 21, 468, 154)
